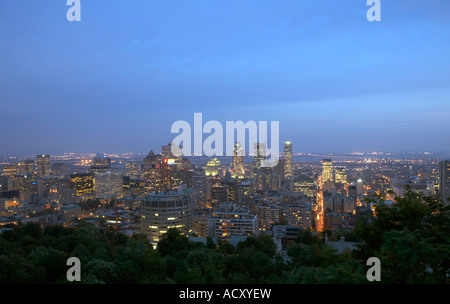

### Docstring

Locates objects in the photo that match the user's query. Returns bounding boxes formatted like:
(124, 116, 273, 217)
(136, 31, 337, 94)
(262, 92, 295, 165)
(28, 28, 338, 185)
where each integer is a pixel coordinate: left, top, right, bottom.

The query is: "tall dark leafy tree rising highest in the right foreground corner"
(356, 189, 450, 283)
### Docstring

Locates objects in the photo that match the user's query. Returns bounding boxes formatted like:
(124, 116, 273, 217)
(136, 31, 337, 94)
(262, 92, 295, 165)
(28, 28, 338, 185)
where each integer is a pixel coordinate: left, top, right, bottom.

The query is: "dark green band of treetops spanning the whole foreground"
(0, 193, 450, 284)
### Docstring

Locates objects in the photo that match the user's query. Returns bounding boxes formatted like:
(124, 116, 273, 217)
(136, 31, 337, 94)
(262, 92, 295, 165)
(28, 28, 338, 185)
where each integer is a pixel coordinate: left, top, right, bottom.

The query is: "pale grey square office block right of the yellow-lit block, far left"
(94, 172, 123, 198)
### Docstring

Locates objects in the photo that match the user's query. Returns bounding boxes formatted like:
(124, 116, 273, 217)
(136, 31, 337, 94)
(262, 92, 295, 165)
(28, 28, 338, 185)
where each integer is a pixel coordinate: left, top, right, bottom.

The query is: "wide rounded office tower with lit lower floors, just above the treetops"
(141, 189, 196, 246)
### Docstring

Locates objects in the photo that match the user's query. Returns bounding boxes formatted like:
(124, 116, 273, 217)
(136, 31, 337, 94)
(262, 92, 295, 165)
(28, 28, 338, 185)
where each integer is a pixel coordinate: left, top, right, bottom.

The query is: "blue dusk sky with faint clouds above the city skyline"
(0, 0, 450, 155)
